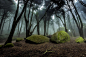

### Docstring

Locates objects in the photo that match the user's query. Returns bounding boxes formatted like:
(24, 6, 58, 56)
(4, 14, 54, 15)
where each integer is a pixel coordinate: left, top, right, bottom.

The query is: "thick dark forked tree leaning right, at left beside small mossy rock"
(5, 0, 28, 44)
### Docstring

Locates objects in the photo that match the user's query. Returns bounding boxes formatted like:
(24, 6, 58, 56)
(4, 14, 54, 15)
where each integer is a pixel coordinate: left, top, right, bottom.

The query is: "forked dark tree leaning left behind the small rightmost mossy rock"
(66, 0, 84, 38)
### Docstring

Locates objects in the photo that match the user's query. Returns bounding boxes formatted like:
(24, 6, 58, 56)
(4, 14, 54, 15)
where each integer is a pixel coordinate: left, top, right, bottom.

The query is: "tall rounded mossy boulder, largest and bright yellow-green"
(50, 31, 70, 43)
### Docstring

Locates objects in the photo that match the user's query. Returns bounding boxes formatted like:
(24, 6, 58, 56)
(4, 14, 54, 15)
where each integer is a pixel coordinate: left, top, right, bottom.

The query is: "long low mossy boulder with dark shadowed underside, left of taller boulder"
(26, 35, 49, 44)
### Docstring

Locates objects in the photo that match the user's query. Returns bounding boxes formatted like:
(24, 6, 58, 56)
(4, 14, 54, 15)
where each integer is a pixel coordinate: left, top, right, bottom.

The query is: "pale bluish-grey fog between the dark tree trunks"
(0, 0, 86, 37)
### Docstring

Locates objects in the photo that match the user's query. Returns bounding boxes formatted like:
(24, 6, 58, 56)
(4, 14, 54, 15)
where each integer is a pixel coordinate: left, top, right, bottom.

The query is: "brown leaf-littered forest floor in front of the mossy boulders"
(0, 39, 86, 57)
